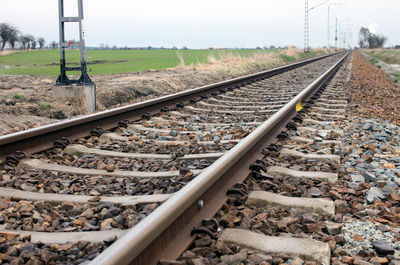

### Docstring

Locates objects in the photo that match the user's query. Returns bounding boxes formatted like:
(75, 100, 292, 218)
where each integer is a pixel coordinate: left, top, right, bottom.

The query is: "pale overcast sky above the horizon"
(0, 0, 400, 48)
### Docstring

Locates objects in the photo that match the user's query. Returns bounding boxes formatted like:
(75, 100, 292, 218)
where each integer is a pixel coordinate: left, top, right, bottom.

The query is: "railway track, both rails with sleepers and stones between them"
(0, 50, 344, 264)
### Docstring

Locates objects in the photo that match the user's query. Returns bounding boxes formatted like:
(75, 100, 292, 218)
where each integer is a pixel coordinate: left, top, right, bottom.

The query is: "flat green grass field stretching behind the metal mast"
(0, 50, 280, 76)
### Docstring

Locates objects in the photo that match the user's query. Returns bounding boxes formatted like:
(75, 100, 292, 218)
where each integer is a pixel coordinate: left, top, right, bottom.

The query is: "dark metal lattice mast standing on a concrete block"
(56, 0, 93, 86)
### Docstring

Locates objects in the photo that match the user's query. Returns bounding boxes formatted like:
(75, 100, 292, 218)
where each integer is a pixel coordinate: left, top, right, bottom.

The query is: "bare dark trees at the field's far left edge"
(0, 23, 46, 51)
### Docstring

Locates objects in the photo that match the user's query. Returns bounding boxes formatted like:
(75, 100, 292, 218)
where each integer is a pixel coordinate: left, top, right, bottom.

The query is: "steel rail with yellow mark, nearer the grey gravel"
(90, 50, 349, 265)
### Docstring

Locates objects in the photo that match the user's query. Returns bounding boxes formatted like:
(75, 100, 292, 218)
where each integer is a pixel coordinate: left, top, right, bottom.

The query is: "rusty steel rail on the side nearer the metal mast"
(0, 53, 337, 160)
